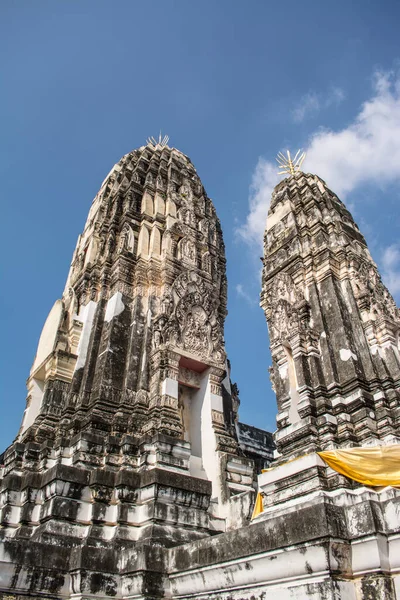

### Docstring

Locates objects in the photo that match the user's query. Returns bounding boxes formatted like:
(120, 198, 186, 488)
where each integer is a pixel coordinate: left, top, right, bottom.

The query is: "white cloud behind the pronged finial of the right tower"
(238, 73, 400, 246)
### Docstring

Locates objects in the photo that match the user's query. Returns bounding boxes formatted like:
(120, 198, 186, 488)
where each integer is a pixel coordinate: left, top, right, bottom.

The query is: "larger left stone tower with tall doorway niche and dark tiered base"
(1, 140, 253, 598)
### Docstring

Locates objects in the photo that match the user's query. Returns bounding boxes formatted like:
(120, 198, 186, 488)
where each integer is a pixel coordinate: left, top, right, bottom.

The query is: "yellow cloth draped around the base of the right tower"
(251, 444, 400, 519)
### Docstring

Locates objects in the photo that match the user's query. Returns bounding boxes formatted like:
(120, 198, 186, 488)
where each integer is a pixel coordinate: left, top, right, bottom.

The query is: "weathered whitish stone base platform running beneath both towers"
(0, 455, 400, 600)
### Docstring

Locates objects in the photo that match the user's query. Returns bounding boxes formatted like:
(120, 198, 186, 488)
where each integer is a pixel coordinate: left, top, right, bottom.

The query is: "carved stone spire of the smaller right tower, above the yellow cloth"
(261, 172, 400, 459)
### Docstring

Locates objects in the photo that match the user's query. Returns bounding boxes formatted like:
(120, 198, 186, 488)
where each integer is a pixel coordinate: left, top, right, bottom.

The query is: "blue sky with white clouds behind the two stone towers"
(0, 0, 400, 450)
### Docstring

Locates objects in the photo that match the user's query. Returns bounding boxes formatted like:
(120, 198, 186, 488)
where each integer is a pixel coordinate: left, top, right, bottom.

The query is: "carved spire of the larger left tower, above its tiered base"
(21, 144, 230, 449)
